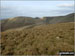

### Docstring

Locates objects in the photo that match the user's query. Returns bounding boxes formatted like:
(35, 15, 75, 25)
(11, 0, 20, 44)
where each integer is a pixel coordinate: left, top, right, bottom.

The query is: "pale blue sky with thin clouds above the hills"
(0, 0, 74, 19)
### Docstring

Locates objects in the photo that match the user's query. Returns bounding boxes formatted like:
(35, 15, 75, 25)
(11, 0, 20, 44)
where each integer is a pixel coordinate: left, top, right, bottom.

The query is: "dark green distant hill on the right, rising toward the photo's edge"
(44, 13, 74, 24)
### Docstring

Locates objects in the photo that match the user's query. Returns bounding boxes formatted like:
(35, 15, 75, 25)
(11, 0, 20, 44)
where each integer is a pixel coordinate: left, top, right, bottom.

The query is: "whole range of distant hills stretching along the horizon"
(1, 13, 74, 31)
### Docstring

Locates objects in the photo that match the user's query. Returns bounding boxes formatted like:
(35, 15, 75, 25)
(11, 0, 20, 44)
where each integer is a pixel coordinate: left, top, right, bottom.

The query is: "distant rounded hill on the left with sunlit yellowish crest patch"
(1, 16, 41, 31)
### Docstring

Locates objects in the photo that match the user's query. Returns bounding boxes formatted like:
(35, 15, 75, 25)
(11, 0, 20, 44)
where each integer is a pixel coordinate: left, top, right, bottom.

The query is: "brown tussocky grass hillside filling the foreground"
(1, 22, 74, 55)
